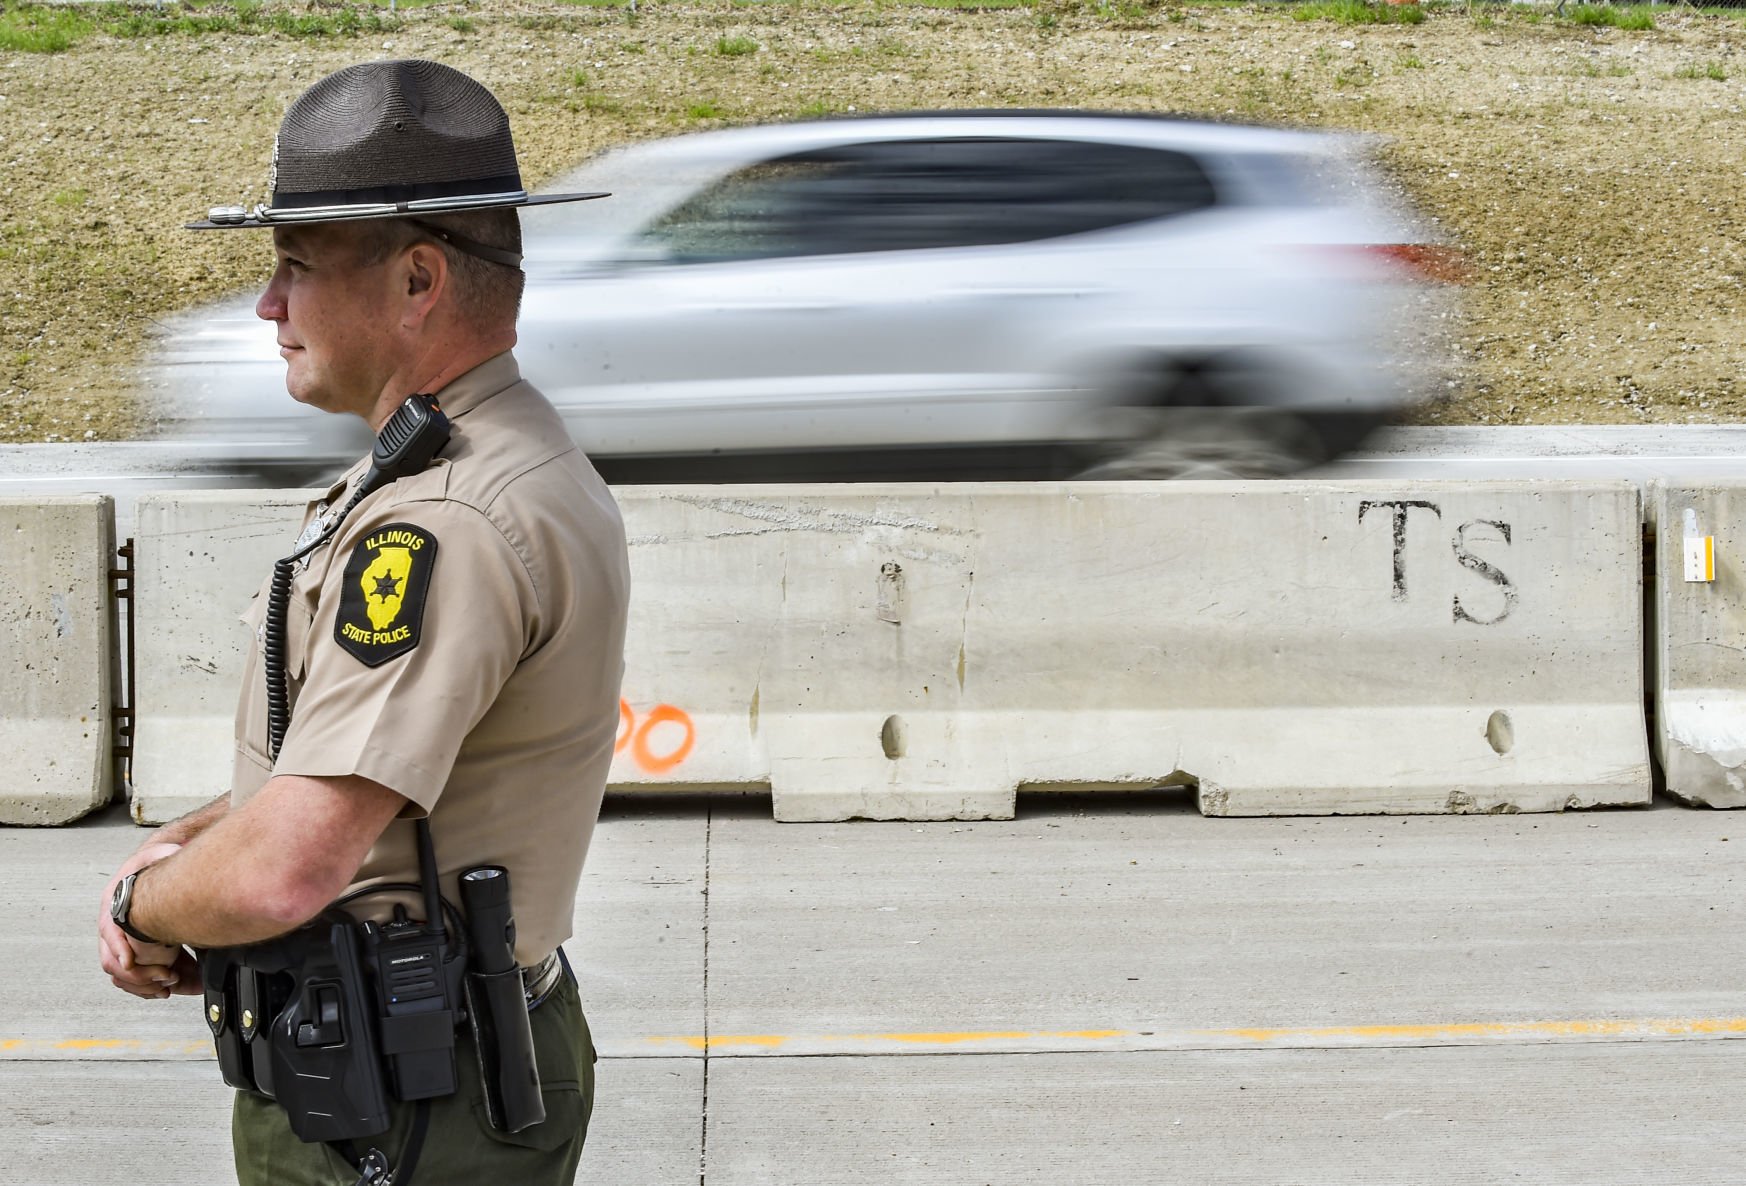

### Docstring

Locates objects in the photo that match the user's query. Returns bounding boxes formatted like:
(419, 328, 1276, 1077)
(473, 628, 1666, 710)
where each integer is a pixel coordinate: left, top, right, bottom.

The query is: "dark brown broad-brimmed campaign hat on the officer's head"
(187, 59, 606, 231)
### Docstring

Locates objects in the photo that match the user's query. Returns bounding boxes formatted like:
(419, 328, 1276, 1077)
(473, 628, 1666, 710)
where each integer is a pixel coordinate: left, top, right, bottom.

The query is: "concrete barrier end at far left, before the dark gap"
(0, 494, 115, 824)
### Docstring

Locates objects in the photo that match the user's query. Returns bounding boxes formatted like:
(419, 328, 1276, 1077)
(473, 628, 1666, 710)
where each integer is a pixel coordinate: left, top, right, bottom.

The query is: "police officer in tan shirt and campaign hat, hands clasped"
(100, 61, 629, 1186)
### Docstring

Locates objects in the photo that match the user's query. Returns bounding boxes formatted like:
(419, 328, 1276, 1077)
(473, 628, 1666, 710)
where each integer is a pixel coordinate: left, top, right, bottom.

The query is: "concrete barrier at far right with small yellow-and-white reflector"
(1650, 480, 1746, 807)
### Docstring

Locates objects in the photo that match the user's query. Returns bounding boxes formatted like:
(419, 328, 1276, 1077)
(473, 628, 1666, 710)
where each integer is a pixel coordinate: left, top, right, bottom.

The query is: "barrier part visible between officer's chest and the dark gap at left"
(133, 491, 320, 823)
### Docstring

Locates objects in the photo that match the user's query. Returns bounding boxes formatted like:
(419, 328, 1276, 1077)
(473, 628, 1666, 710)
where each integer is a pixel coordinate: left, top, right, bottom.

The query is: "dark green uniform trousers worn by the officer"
(230, 975, 594, 1186)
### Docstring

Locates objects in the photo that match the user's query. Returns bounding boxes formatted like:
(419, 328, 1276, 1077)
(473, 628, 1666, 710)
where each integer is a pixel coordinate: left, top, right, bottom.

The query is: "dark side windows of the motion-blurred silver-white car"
(637, 138, 1215, 264)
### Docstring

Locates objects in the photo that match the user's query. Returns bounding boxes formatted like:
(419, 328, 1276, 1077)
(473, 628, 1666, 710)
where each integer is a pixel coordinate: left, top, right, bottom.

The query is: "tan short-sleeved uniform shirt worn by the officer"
(230, 353, 630, 964)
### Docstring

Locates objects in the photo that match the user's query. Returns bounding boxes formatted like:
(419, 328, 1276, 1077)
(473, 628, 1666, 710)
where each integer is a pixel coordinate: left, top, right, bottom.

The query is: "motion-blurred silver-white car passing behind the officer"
(152, 112, 1451, 480)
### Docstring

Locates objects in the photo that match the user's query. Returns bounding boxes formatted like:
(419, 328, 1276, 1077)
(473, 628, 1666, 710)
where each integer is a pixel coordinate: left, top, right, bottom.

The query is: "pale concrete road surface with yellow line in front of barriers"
(0, 793, 1746, 1186)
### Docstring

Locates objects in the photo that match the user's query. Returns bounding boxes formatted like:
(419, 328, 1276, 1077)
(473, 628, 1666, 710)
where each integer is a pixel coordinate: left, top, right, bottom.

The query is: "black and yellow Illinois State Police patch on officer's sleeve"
(333, 522, 437, 667)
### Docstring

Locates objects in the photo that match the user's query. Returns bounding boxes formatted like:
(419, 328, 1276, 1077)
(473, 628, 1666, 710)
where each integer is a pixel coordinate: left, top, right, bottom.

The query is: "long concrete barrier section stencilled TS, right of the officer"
(613, 482, 1650, 819)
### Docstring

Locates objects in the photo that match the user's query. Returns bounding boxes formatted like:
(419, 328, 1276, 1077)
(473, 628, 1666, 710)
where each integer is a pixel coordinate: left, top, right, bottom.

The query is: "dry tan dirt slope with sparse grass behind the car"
(0, 0, 1746, 442)
